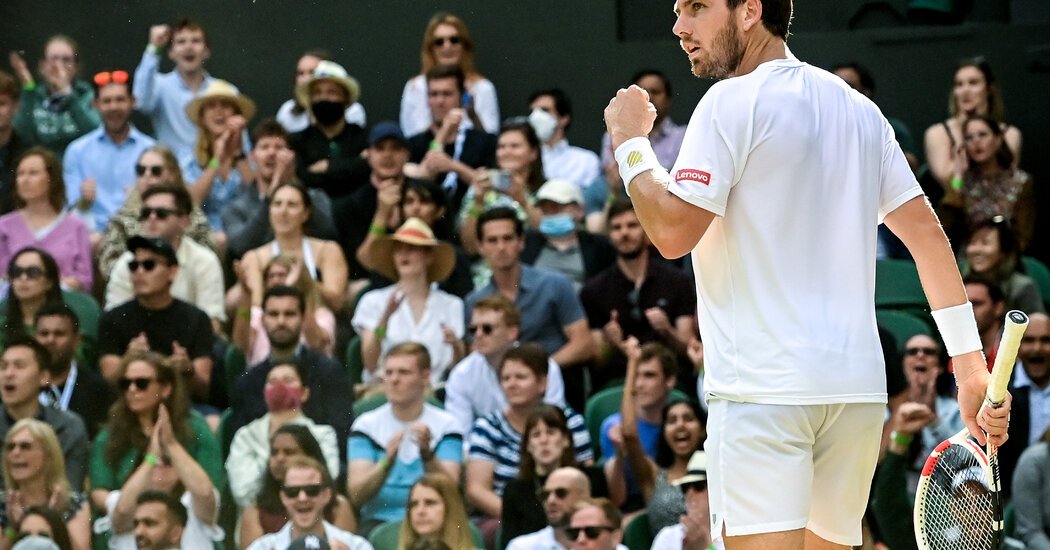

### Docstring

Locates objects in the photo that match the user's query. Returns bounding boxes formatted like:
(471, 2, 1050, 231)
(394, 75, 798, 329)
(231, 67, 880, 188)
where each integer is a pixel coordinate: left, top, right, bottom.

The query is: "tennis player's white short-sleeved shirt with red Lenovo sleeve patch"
(669, 52, 922, 404)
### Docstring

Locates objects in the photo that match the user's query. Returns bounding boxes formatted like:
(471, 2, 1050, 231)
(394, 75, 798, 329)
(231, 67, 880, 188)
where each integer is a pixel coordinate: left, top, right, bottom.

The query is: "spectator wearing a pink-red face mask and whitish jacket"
(226, 360, 339, 509)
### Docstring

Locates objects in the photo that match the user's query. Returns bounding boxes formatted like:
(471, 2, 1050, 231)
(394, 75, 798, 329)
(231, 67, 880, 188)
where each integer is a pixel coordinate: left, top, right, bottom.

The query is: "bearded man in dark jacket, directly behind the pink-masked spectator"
(227, 287, 354, 461)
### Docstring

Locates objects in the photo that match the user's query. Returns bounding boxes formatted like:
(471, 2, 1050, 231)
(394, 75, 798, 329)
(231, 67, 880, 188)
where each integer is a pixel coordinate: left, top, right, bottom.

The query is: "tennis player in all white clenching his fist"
(605, 0, 1009, 550)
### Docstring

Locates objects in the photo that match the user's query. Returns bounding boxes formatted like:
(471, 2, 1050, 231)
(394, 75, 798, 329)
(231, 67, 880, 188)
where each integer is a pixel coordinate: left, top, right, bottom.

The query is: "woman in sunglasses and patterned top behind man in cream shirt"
(96, 145, 212, 280)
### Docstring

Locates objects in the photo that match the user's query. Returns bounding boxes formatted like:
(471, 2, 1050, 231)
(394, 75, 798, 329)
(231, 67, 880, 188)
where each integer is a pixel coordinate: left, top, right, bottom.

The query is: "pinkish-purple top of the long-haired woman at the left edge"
(0, 210, 91, 293)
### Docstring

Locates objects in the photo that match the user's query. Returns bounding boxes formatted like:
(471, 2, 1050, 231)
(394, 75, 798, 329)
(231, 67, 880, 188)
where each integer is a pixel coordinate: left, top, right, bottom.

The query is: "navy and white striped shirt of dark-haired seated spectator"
(469, 407, 594, 496)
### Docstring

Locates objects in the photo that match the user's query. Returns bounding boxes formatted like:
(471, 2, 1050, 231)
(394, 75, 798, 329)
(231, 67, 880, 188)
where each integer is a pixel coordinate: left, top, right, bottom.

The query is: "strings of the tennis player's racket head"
(924, 445, 998, 550)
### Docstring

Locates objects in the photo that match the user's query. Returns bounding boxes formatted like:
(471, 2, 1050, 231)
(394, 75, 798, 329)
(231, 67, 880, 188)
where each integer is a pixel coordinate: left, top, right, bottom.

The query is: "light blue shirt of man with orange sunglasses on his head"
(62, 126, 156, 232)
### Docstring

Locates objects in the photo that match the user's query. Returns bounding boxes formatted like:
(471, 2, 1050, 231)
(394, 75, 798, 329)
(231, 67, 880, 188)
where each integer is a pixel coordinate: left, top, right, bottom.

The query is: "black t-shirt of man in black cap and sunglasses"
(99, 298, 215, 359)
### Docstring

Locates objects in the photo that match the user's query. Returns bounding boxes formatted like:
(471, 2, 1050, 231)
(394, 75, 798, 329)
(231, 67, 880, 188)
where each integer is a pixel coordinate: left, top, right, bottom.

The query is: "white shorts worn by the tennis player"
(705, 399, 886, 546)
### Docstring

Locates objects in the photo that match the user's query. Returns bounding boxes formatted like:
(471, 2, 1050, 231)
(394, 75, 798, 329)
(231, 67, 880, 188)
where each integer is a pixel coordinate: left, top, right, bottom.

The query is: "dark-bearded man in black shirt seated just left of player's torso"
(580, 200, 696, 388)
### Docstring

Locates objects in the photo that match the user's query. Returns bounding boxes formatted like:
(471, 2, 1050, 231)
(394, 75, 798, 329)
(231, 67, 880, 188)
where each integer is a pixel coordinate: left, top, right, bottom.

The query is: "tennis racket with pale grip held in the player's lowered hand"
(915, 311, 1028, 550)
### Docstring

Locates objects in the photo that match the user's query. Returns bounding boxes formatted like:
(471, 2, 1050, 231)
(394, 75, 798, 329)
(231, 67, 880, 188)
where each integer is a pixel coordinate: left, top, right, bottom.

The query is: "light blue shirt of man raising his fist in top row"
(133, 48, 223, 155)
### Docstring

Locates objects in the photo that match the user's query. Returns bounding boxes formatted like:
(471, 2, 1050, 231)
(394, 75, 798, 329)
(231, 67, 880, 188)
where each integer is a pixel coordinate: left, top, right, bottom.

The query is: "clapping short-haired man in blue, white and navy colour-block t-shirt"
(347, 342, 463, 533)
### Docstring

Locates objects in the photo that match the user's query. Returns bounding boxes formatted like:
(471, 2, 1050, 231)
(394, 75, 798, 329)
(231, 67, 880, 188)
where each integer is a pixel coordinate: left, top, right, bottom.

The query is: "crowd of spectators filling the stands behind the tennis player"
(0, 8, 1050, 550)
